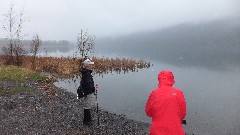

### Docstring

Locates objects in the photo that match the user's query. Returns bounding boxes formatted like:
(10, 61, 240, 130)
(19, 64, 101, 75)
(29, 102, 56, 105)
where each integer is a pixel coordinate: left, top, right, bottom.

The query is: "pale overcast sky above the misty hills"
(0, 0, 240, 41)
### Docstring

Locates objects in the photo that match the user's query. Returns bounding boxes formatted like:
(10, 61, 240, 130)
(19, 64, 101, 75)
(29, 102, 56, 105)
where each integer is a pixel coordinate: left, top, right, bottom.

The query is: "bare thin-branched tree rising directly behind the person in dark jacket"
(77, 30, 95, 58)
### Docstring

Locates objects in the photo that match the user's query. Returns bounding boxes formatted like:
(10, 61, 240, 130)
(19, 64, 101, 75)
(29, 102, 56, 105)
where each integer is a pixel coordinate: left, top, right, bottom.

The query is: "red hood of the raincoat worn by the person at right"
(158, 70, 175, 86)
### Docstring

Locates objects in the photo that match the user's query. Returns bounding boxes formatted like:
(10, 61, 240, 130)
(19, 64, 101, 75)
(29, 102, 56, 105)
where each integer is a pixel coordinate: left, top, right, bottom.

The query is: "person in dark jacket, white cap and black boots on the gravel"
(81, 59, 95, 125)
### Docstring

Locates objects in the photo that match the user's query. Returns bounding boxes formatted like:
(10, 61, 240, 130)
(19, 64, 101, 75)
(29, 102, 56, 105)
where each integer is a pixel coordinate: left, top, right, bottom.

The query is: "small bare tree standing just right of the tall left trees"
(30, 34, 41, 70)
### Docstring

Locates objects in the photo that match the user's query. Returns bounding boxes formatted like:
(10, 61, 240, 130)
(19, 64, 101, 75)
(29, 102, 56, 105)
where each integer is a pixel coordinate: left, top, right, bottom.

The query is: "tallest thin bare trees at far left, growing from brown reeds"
(2, 3, 26, 65)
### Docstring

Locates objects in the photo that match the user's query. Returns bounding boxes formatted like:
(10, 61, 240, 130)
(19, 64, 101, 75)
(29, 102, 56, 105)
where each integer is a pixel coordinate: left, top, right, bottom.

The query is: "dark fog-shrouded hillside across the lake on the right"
(96, 18, 240, 69)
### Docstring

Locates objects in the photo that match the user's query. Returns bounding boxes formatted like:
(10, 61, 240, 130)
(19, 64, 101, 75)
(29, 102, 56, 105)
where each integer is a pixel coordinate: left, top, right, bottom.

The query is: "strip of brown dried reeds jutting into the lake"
(0, 55, 150, 77)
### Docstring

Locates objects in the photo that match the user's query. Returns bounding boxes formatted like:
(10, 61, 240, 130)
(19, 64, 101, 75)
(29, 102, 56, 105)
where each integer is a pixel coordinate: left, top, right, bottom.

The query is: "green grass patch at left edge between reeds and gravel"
(0, 65, 46, 96)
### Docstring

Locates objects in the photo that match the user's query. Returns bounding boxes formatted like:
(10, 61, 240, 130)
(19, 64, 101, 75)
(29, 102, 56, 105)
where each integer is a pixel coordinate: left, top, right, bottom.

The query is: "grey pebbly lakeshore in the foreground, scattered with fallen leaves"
(0, 81, 149, 135)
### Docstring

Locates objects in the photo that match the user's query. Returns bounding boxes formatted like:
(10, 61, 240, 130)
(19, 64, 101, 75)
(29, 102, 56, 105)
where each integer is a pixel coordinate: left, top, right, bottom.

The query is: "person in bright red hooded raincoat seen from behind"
(145, 71, 186, 135)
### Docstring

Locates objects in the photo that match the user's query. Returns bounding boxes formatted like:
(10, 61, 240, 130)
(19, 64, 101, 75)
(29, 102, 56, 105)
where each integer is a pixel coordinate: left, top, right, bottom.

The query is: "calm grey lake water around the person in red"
(55, 61, 240, 135)
